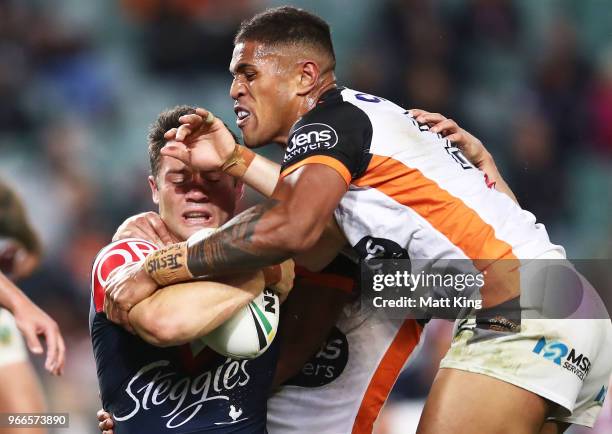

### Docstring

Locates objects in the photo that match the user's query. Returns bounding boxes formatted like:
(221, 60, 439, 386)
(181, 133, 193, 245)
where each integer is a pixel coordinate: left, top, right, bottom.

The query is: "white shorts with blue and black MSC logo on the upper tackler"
(440, 318, 612, 427)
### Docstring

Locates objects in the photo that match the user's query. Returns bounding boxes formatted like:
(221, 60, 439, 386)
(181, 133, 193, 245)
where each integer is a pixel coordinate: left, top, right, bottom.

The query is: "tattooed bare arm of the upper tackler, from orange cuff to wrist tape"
(179, 164, 347, 276)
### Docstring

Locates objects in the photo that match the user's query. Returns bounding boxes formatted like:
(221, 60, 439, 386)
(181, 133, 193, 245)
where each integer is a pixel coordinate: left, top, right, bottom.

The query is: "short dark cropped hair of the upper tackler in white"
(234, 6, 336, 69)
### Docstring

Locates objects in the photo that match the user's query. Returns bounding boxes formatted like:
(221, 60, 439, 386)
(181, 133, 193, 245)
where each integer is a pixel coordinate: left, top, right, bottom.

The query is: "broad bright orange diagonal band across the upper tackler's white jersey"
(353, 155, 520, 307)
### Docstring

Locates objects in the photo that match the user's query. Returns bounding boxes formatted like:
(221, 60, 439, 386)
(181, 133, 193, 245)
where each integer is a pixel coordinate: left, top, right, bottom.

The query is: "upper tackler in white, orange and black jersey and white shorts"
(103, 7, 612, 433)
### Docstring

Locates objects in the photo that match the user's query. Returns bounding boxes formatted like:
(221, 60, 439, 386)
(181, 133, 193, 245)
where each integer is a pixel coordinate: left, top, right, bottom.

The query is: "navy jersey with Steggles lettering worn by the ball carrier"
(89, 239, 278, 434)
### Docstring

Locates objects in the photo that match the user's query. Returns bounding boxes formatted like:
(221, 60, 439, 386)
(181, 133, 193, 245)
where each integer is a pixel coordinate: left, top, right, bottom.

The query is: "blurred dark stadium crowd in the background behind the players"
(0, 0, 612, 433)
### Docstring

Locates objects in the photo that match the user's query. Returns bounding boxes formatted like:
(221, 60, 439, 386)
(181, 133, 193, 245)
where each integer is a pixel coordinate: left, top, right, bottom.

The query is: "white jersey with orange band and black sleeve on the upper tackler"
(281, 88, 565, 302)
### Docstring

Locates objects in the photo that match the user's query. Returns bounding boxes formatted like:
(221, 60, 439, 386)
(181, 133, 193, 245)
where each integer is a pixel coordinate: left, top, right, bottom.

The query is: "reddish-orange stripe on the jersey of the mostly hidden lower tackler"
(352, 319, 422, 434)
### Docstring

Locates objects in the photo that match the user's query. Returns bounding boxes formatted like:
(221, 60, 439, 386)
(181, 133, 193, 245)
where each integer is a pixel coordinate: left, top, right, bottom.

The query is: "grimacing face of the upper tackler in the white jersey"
(230, 41, 298, 147)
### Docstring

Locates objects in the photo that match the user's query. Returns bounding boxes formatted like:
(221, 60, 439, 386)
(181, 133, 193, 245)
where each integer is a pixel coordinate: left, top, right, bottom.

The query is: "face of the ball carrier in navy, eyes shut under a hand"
(149, 156, 242, 239)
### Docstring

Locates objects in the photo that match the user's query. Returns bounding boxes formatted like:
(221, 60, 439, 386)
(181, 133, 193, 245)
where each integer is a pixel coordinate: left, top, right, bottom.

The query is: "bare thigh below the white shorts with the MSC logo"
(417, 369, 550, 434)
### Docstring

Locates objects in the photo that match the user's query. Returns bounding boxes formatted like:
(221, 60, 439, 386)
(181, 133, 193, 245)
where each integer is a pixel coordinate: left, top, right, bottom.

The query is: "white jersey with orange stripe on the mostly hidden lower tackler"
(267, 255, 423, 434)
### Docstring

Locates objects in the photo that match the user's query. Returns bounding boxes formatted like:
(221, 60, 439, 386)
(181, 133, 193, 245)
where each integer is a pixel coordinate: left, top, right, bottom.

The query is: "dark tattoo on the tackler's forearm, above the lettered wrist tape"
(187, 199, 289, 276)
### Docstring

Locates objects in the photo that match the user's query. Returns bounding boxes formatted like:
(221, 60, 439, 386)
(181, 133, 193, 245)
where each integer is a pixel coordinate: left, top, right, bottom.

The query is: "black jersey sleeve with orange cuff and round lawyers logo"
(281, 101, 372, 186)
